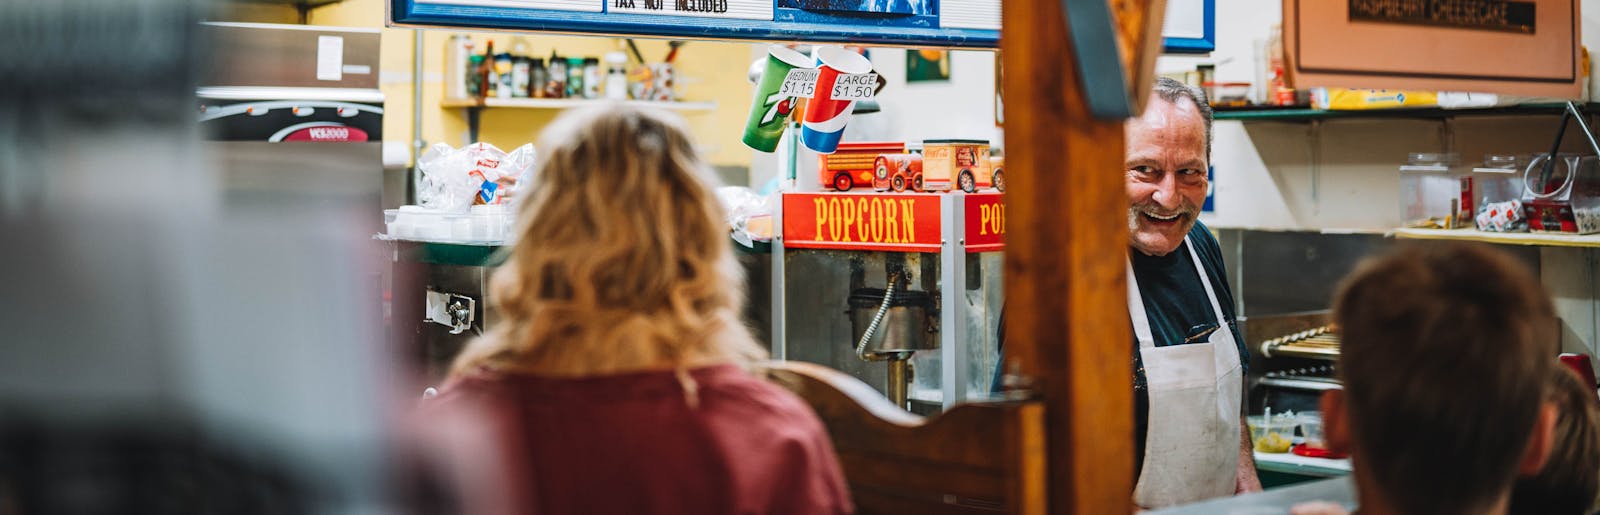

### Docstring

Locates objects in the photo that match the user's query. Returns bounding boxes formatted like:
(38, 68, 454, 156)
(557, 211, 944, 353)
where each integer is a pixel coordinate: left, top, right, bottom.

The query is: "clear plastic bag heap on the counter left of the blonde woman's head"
(416, 142, 534, 213)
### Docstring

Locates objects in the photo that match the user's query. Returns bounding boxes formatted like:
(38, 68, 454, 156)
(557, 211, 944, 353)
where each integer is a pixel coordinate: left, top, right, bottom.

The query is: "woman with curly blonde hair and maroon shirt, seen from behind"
(432, 104, 851, 513)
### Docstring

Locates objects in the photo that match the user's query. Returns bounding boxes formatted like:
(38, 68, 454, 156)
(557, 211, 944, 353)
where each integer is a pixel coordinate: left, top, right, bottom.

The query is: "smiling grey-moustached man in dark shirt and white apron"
(1123, 78, 1261, 507)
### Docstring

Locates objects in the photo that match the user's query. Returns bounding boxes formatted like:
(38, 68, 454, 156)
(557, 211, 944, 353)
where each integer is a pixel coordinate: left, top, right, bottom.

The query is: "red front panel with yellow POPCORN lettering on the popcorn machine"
(784, 194, 942, 253)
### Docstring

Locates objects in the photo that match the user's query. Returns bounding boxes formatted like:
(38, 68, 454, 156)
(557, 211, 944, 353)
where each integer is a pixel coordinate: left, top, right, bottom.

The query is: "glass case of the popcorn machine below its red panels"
(771, 237, 1003, 414)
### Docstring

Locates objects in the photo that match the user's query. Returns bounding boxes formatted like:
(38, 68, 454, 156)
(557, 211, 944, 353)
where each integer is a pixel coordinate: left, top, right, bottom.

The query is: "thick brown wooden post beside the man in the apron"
(1000, 0, 1162, 513)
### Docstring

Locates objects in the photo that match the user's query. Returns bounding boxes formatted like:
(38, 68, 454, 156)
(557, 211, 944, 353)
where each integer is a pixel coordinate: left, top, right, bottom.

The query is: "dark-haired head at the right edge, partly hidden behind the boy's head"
(1510, 368, 1600, 515)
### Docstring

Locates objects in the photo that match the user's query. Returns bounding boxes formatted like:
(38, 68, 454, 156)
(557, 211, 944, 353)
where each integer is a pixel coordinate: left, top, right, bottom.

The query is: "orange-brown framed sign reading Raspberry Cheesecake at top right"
(1283, 0, 1584, 98)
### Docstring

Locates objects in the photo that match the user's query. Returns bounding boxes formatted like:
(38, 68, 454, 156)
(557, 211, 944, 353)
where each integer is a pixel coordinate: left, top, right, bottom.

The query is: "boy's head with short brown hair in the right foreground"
(1323, 243, 1557, 513)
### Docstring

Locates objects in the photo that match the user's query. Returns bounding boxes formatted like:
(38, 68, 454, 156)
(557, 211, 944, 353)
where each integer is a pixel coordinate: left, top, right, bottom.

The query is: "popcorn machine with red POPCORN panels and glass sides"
(771, 192, 1005, 413)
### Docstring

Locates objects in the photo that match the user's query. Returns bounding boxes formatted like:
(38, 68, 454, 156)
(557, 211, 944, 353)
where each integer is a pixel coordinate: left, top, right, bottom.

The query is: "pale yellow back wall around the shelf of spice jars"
(230, 0, 752, 166)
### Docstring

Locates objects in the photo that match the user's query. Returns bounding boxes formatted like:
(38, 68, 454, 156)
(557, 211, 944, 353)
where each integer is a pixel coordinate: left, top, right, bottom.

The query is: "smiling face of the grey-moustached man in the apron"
(1123, 94, 1206, 256)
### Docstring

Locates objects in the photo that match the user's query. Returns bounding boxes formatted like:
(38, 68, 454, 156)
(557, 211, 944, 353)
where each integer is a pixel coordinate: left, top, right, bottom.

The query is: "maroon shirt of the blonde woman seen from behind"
(424, 365, 853, 515)
